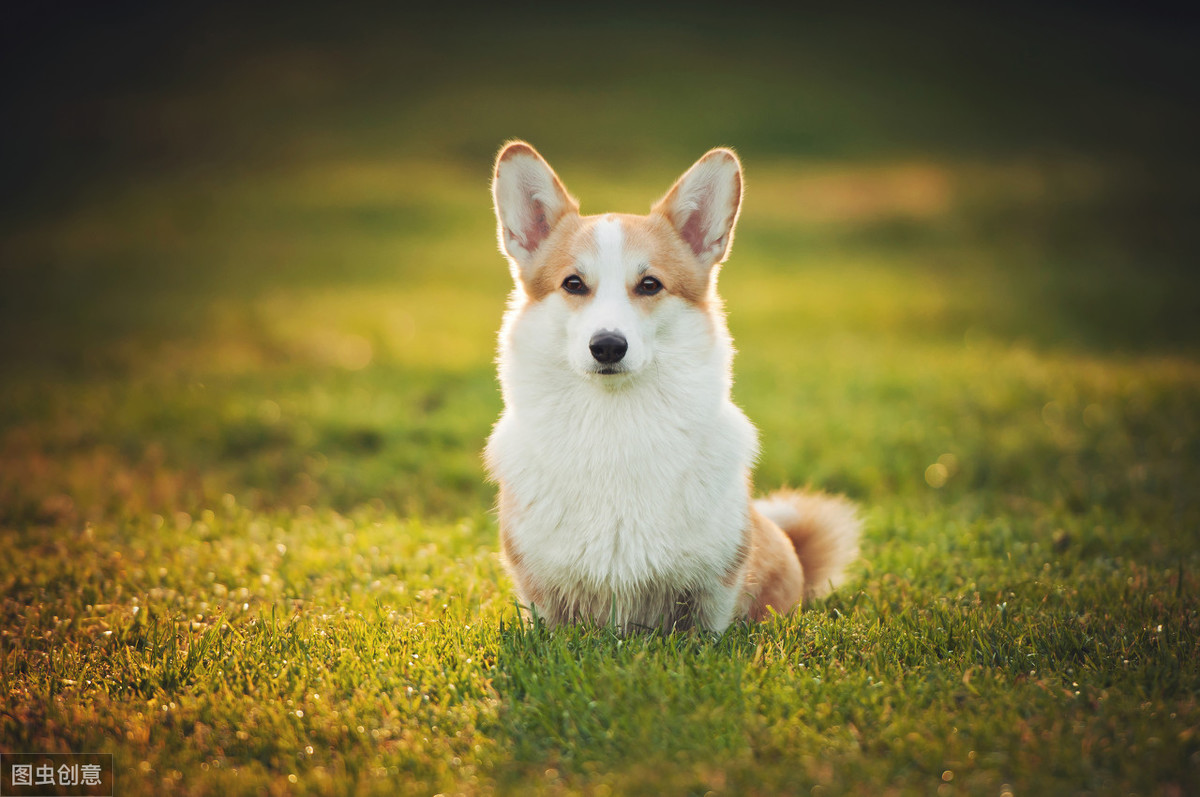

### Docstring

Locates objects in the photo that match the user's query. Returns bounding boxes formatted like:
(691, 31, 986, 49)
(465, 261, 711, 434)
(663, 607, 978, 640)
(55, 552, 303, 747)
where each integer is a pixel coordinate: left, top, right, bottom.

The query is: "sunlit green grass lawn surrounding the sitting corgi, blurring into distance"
(0, 4, 1200, 796)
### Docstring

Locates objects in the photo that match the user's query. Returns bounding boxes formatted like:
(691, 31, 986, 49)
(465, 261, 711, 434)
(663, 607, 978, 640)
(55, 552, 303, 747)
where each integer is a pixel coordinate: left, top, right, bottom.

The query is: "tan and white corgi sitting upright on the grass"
(485, 142, 859, 634)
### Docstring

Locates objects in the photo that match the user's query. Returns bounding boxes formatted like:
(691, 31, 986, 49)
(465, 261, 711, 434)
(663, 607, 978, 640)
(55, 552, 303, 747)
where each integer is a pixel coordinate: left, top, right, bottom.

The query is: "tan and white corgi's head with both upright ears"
(492, 142, 742, 384)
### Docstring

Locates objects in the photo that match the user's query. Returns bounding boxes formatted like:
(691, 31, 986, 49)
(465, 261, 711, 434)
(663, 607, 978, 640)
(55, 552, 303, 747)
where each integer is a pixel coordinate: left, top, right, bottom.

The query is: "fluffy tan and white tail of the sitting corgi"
(754, 490, 863, 600)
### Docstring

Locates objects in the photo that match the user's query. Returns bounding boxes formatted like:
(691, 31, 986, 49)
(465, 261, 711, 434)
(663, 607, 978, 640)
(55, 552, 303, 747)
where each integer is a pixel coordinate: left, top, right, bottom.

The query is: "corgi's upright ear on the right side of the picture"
(652, 149, 742, 268)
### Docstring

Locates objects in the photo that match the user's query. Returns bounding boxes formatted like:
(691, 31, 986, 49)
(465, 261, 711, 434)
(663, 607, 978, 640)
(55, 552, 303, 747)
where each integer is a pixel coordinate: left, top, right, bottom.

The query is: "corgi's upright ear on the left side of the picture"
(492, 142, 580, 277)
